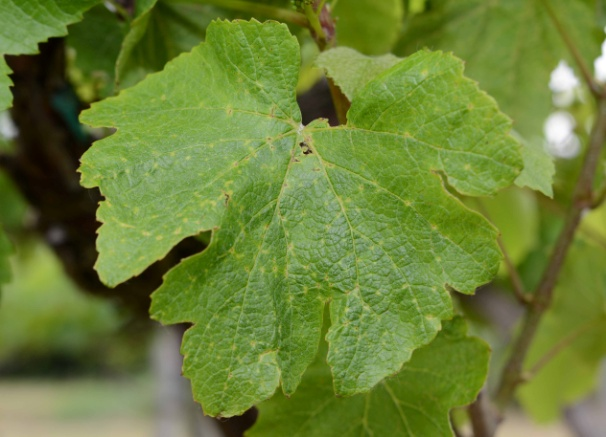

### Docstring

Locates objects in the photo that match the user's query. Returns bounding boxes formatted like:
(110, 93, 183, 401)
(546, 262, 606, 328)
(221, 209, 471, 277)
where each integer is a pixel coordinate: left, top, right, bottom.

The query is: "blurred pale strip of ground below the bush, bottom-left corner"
(0, 377, 154, 437)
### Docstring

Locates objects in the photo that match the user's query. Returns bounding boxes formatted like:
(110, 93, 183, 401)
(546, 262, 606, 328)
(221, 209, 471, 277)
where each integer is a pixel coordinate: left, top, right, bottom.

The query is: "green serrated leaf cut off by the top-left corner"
(0, 0, 100, 111)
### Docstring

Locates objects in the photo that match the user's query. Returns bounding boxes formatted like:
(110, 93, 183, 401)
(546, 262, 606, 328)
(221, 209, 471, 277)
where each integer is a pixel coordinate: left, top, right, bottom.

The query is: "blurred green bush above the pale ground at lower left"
(0, 244, 146, 376)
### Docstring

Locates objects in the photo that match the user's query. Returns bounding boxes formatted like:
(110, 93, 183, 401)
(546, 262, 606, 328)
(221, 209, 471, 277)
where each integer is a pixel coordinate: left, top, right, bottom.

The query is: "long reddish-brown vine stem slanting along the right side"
(495, 96, 606, 411)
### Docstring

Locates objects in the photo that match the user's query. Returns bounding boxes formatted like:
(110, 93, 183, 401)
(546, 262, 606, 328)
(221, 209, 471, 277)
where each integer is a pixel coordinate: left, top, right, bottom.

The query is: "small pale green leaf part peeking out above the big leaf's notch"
(316, 47, 401, 101)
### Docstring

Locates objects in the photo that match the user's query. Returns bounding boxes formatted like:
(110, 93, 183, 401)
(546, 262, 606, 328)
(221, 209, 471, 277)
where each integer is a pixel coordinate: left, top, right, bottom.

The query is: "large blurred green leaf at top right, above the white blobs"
(395, 0, 604, 137)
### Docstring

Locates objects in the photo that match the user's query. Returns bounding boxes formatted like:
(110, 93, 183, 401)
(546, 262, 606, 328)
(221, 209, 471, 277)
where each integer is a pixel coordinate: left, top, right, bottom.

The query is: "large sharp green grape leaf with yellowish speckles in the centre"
(81, 21, 521, 416)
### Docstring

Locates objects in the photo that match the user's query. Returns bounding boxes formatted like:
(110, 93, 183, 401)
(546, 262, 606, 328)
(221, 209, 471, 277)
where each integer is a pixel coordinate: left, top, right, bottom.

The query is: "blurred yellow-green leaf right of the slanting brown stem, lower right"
(518, 242, 606, 421)
